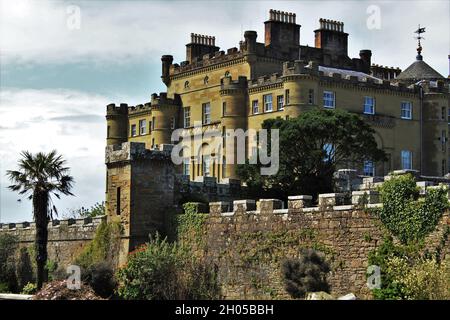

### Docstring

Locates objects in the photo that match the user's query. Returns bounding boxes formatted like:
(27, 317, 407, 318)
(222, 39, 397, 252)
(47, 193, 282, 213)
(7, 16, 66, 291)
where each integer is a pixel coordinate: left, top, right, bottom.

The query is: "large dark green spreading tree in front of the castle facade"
(237, 108, 386, 199)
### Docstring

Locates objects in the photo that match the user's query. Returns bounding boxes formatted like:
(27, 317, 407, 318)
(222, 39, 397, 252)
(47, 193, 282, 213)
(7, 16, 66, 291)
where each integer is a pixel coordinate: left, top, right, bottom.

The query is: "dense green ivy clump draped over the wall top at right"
(379, 174, 448, 244)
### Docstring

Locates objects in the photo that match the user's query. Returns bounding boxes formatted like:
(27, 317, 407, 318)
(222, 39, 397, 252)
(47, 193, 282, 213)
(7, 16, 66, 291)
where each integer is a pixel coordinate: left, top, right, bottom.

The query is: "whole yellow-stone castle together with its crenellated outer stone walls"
(0, 10, 450, 299)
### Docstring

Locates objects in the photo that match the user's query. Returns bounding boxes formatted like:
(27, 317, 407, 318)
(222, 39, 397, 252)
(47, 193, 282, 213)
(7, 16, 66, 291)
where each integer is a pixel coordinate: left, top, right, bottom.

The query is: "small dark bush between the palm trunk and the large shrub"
(82, 263, 117, 298)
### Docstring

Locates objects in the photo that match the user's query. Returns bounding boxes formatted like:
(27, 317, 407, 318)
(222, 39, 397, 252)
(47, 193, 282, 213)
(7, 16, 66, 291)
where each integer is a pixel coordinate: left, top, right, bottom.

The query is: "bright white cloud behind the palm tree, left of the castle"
(0, 88, 108, 222)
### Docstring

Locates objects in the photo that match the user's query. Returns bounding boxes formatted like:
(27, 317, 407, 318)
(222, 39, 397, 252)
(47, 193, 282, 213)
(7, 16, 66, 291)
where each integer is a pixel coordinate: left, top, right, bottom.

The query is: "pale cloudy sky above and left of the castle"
(0, 0, 450, 222)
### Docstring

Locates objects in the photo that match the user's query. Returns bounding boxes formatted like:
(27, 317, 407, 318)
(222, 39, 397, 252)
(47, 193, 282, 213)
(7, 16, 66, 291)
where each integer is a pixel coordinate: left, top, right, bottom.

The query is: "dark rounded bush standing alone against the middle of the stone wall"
(281, 249, 330, 299)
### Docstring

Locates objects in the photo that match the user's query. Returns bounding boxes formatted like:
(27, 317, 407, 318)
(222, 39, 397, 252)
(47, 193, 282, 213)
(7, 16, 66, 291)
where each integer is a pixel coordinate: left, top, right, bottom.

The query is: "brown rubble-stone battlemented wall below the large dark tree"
(206, 198, 450, 299)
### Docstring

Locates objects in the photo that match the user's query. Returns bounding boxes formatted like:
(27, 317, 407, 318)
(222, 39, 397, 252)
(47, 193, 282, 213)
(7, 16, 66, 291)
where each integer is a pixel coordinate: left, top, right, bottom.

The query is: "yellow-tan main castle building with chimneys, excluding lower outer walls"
(106, 10, 450, 182)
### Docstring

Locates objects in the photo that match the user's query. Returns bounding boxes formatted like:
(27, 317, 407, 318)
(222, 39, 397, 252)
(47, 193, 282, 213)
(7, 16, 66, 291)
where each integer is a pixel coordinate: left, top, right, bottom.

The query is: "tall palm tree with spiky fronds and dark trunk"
(6, 150, 74, 289)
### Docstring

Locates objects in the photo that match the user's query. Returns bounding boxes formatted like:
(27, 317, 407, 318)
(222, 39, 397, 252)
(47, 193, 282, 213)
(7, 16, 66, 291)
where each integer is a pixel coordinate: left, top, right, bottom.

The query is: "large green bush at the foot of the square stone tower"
(117, 235, 220, 300)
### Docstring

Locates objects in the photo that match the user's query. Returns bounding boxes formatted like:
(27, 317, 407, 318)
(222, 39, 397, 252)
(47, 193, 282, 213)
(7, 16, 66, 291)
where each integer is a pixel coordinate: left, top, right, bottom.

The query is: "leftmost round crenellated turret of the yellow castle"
(106, 103, 128, 145)
